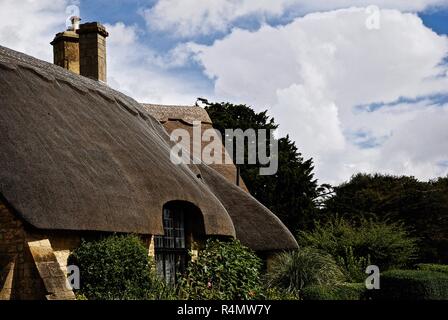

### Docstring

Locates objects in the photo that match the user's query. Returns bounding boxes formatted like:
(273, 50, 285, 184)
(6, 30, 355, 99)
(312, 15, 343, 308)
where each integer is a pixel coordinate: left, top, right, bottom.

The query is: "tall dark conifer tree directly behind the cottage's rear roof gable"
(205, 103, 323, 233)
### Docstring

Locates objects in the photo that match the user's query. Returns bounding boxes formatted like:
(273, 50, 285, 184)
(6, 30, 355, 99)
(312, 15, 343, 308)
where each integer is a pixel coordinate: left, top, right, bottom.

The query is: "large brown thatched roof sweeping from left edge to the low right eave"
(0, 46, 297, 251)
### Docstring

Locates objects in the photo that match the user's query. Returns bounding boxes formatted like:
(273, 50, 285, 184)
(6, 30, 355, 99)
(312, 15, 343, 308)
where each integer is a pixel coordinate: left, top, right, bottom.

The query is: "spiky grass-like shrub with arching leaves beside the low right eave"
(268, 248, 344, 293)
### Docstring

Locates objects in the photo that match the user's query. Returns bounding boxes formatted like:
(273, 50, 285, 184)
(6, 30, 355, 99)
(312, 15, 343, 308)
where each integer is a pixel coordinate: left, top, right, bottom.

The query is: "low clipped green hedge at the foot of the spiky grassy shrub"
(300, 283, 366, 300)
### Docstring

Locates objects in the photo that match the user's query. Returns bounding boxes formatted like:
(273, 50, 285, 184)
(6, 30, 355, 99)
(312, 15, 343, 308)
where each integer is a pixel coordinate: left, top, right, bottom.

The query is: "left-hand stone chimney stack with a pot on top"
(51, 17, 81, 74)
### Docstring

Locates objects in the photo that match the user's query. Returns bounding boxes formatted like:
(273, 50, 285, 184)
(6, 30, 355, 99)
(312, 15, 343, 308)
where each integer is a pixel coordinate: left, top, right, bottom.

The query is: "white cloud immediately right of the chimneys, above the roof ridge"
(106, 22, 201, 104)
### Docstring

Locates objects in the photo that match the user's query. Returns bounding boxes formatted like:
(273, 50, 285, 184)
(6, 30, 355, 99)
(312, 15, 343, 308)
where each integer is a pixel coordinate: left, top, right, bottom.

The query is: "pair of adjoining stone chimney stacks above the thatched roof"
(51, 17, 109, 82)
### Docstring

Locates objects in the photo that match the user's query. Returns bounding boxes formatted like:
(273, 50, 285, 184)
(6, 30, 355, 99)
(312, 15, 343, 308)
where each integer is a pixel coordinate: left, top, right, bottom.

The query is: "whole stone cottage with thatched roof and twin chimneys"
(0, 18, 297, 299)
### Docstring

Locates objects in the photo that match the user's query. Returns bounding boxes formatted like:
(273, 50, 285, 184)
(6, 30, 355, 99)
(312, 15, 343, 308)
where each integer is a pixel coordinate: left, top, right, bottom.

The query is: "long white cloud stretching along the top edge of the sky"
(143, 0, 448, 37)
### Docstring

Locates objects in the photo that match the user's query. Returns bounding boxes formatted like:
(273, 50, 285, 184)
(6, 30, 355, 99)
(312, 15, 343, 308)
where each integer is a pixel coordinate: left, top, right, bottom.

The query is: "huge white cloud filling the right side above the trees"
(190, 8, 448, 182)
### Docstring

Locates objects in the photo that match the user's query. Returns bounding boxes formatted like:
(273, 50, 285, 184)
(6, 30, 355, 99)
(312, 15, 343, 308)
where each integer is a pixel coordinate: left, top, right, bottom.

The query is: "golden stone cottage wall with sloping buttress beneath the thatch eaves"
(0, 201, 158, 300)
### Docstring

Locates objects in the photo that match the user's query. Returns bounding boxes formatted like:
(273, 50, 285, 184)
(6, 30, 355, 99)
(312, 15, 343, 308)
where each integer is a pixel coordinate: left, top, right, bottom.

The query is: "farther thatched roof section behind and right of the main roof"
(143, 104, 297, 251)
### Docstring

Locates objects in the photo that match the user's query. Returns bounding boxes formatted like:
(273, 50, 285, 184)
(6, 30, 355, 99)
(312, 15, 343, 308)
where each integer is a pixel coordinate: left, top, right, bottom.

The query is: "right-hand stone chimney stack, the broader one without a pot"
(76, 22, 109, 82)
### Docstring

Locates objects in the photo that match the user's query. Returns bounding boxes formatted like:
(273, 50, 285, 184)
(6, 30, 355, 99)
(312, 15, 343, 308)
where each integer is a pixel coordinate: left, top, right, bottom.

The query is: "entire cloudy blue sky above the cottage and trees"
(0, 0, 448, 183)
